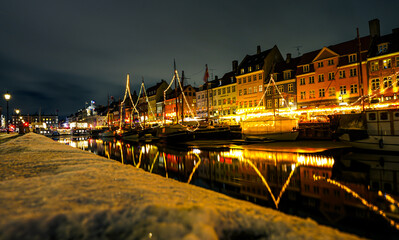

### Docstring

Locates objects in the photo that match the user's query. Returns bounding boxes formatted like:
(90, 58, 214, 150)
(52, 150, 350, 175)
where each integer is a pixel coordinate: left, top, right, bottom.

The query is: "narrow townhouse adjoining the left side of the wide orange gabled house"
(265, 54, 300, 111)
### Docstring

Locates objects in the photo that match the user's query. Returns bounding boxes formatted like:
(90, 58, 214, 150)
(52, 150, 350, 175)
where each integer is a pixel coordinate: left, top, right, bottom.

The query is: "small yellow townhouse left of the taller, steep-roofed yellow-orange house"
(211, 71, 237, 118)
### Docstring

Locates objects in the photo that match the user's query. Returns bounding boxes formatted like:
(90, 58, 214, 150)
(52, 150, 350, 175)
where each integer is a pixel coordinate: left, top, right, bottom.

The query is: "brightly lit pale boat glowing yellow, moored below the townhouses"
(241, 115, 299, 141)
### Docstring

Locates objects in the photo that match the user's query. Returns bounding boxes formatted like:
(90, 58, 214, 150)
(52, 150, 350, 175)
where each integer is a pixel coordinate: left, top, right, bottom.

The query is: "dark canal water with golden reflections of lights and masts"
(57, 137, 399, 239)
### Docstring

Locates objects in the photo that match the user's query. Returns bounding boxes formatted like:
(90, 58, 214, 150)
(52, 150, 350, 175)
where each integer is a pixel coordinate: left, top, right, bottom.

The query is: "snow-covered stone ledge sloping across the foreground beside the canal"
(0, 133, 358, 239)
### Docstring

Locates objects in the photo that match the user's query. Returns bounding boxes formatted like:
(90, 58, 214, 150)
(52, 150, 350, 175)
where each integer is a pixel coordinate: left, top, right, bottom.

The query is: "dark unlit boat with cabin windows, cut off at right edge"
(339, 109, 399, 152)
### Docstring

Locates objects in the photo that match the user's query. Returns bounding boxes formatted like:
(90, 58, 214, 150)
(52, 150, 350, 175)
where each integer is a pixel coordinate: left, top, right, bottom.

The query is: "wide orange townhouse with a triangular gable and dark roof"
(296, 36, 370, 109)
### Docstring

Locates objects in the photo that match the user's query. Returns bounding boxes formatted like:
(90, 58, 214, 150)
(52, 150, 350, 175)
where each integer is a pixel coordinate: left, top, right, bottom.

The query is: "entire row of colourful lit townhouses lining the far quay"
(70, 19, 399, 129)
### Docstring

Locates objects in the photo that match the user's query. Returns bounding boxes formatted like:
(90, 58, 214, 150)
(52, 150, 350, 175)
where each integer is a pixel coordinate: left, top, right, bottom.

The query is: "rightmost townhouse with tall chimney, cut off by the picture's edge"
(365, 19, 399, 104)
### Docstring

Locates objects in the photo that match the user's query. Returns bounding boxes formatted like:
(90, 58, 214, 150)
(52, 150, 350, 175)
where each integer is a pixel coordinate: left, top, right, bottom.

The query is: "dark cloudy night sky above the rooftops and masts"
(0, 0, 399, 116)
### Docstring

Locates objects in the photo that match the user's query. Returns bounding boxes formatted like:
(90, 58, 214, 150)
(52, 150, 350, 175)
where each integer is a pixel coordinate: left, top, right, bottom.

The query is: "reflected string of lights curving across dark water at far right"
(313, 175, 399, 230)
